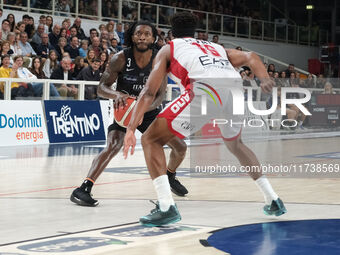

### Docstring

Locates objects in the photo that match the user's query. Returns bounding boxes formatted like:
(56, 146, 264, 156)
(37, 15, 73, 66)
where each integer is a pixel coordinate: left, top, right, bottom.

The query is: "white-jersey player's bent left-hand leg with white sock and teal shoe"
(140, 118, 181, 226)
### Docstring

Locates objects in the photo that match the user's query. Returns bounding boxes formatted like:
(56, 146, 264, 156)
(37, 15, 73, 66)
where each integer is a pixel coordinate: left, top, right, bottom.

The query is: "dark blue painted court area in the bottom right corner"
(208, 219, 340, 255)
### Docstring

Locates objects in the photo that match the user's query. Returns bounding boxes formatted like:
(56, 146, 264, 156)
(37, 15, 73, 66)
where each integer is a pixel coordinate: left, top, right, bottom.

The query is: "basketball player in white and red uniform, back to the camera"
(124, 12, 286, 226)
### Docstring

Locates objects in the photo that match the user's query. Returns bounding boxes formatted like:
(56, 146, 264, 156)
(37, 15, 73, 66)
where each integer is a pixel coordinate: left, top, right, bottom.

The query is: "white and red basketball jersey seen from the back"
(168, 38, 241, 90)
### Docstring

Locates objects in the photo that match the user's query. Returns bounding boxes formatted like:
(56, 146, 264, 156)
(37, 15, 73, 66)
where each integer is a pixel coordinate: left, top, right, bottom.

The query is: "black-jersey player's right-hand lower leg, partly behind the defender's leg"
(167, 136, 188, 196)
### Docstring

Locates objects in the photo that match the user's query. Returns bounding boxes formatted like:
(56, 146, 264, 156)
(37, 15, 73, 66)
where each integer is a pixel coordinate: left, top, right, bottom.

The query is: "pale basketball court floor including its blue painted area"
(0, 132, 340, 255)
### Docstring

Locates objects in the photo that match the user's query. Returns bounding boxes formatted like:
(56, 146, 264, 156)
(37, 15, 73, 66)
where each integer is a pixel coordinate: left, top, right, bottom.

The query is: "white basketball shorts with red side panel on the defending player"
(157, 80, 244, 141)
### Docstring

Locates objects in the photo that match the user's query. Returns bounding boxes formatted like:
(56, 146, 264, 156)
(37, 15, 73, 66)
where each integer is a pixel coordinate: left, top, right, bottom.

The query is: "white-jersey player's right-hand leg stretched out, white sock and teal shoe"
(224, 133, 287, 216)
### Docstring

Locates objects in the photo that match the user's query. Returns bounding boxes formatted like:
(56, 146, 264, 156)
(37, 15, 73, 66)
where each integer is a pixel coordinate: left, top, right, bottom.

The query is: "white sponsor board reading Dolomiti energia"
(0, 100, 49, 146)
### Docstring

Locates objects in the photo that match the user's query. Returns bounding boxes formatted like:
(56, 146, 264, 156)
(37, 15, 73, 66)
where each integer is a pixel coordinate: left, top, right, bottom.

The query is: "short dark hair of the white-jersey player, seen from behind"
(170, 12, 198, 37)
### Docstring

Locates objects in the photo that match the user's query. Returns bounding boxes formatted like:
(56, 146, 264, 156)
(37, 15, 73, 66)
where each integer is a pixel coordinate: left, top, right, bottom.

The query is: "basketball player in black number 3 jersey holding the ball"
(70, 21, 188, 206)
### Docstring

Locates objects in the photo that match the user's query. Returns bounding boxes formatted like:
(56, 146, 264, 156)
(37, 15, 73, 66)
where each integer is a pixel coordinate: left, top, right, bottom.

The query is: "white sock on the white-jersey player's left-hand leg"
(153, 174, 175, 212)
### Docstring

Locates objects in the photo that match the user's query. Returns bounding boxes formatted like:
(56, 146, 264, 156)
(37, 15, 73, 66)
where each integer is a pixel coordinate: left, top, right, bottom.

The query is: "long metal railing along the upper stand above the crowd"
(0, 0, 328, 45)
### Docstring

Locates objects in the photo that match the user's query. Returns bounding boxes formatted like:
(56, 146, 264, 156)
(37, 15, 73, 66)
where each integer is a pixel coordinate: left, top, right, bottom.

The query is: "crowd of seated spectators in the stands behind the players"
(0, 6, 332, 99)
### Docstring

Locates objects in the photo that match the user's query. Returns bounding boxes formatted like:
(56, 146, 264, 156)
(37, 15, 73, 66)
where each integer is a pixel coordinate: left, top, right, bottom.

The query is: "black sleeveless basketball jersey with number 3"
(116, 48, 157, 97)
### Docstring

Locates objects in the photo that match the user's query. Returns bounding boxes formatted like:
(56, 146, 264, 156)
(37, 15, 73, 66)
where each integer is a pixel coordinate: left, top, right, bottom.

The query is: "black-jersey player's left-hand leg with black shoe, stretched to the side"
(70, 128, 125, 206)
